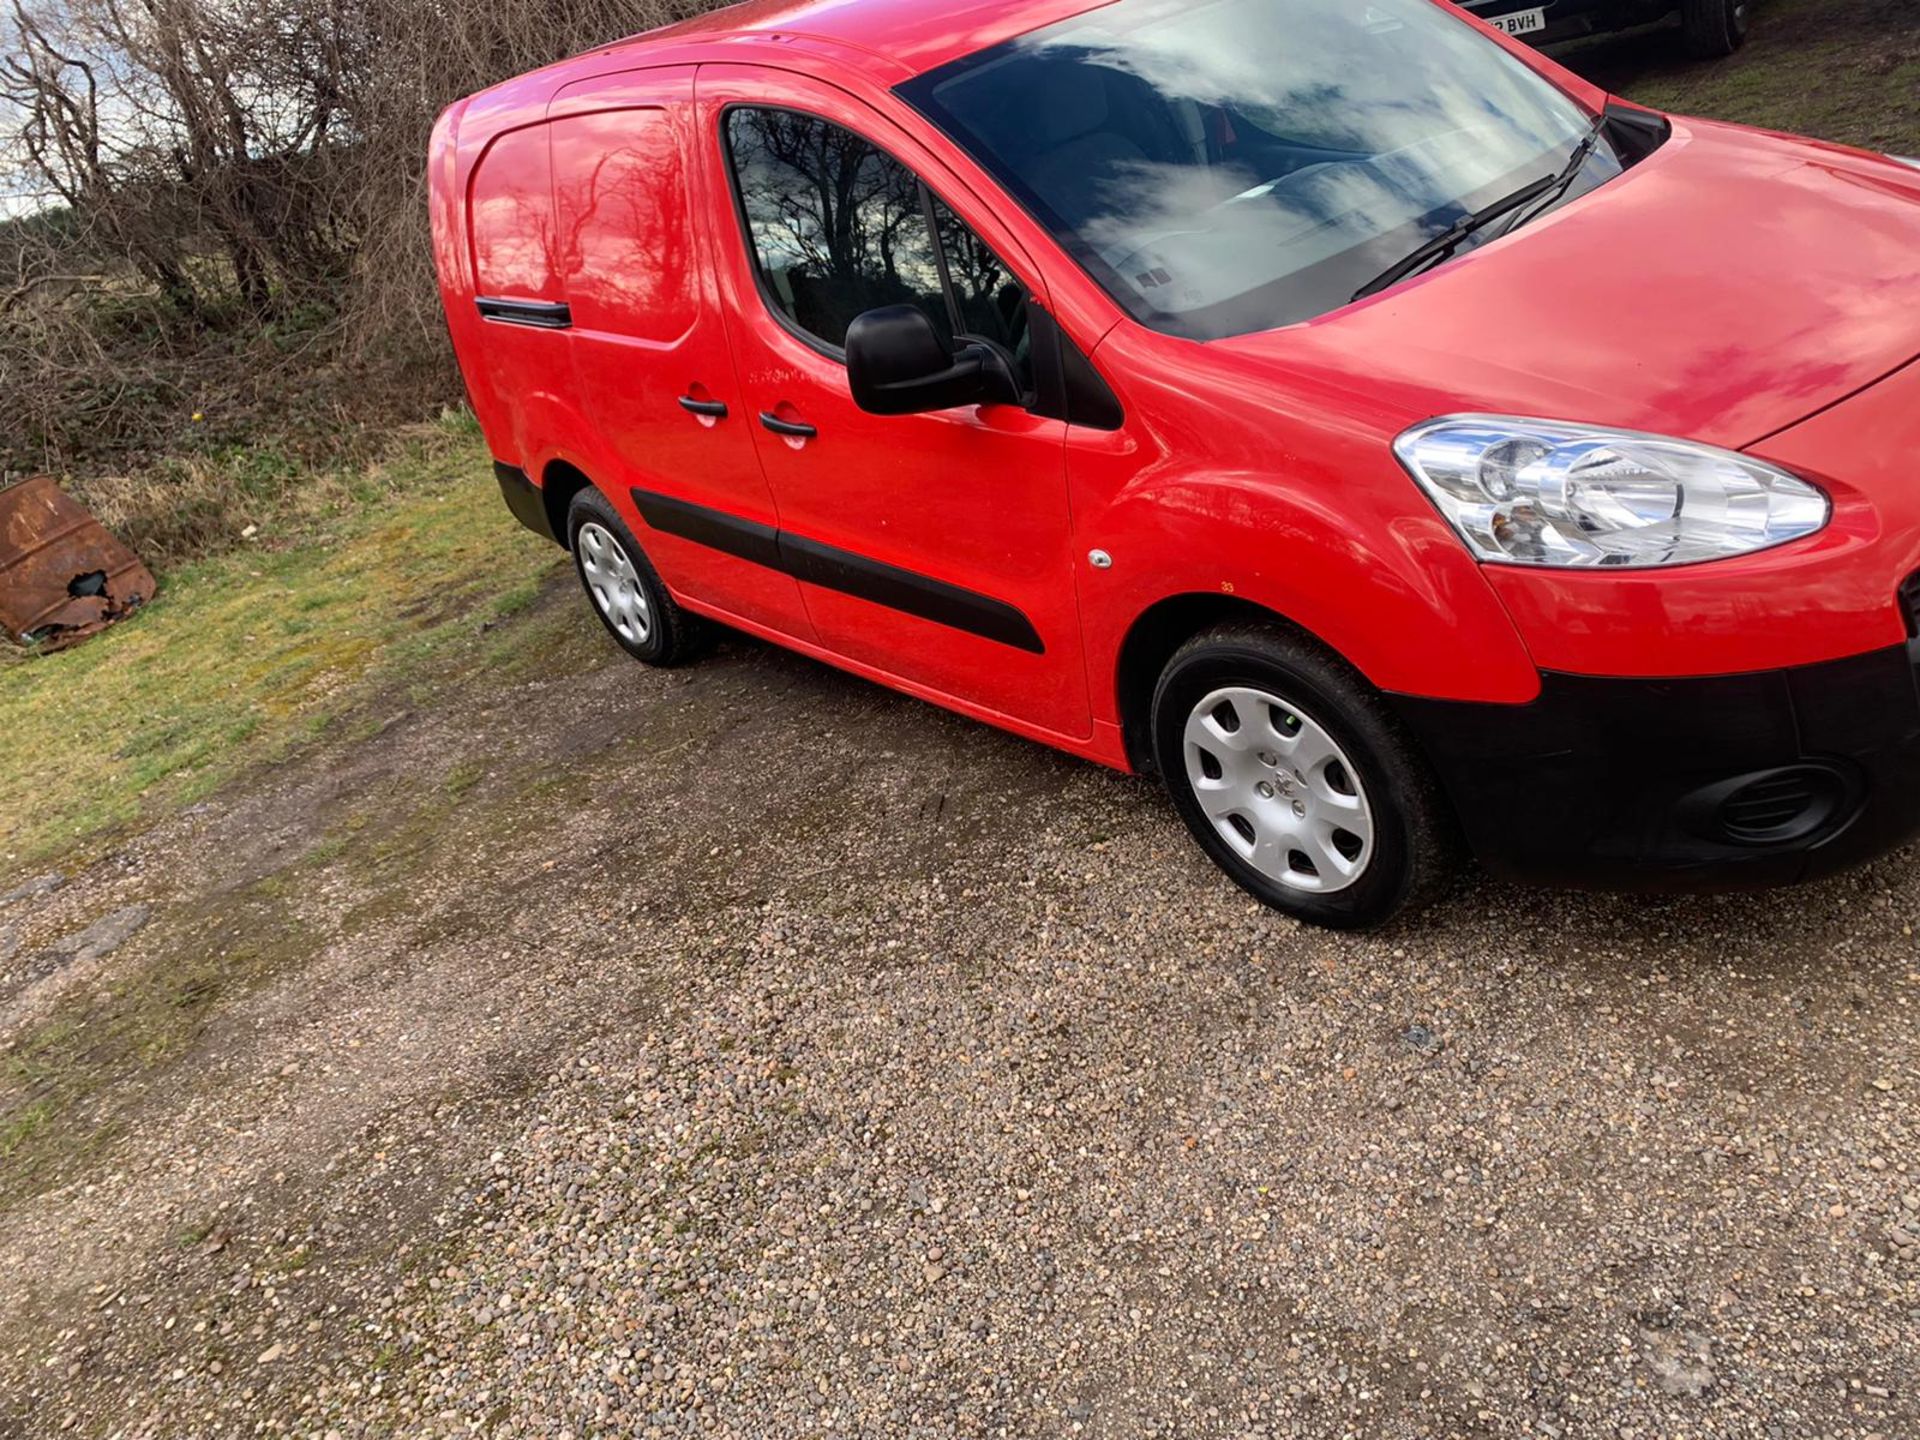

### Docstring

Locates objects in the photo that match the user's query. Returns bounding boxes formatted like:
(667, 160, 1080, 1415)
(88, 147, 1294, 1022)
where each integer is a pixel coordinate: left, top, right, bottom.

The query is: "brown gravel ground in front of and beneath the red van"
(0, 582, 1920, 1440)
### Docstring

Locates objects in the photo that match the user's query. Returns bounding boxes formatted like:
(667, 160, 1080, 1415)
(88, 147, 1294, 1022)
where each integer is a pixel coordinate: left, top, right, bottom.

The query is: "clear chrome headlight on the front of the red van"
(1394, 415, 1832, 568)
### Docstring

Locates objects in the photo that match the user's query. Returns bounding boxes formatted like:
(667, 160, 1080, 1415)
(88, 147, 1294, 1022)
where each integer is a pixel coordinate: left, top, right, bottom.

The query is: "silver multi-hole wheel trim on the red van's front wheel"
(1183, 685, 1375, 895)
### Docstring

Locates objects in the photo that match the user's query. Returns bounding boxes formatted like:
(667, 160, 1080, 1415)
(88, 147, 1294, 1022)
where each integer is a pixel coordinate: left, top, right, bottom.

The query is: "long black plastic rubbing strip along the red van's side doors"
(630, 490, 1046, 655)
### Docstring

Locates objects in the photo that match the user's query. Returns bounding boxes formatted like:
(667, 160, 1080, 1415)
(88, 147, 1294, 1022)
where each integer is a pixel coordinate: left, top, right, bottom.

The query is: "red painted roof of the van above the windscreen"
(616, 0, 1112, 75)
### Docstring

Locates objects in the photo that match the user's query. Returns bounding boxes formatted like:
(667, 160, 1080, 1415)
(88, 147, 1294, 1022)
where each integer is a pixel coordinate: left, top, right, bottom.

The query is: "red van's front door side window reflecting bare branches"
(726, 108, 1025, 384)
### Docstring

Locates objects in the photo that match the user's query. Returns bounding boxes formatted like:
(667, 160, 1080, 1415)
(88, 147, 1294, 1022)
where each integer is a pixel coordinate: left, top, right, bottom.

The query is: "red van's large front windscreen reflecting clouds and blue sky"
(900, 0, 1620, 340)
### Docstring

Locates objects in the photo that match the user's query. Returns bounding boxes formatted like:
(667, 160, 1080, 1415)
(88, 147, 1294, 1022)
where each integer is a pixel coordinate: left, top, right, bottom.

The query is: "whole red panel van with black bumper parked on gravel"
(432, 0, 1920, 925)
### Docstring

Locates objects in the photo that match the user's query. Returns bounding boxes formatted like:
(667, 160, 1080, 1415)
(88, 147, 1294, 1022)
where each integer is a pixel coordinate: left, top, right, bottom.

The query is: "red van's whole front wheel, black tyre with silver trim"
(1154, 624, 1457, 929)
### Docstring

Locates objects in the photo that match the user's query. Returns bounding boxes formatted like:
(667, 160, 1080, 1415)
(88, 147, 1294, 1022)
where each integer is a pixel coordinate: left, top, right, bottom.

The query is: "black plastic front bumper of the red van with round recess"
(1394, 641, 1920, 891)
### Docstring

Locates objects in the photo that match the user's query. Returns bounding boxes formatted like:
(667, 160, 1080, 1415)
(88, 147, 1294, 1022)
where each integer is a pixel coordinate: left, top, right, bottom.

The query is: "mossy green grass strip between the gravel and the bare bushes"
(0, 426, 563, 874)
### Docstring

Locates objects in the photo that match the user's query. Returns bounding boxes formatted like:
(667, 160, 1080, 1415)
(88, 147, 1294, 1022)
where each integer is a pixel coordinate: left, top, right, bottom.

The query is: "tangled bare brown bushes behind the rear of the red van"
(0, 0, 708, 480)
